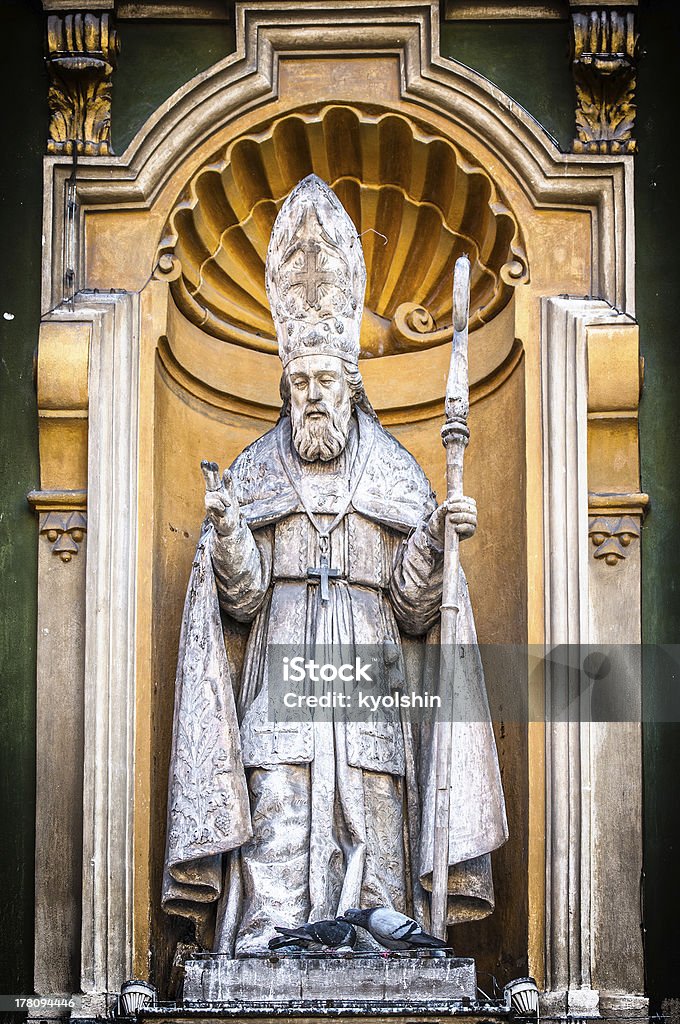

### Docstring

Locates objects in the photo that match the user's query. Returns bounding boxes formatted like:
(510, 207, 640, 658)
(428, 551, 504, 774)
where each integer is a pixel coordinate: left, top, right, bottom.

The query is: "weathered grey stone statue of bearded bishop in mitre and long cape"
(162, 175, 507, 956)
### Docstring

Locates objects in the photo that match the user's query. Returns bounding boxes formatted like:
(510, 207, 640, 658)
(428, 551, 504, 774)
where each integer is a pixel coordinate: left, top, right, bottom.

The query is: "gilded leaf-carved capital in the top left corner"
(46, 11, 119, 157)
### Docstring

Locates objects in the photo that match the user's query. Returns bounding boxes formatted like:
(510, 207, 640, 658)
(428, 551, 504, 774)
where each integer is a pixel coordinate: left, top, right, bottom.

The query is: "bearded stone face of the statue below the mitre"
(286, 355, 352, 462)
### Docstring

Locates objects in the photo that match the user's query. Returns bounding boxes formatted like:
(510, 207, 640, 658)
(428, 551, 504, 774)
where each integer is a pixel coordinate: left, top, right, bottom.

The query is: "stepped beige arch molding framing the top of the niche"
(43, 0, 635, 313)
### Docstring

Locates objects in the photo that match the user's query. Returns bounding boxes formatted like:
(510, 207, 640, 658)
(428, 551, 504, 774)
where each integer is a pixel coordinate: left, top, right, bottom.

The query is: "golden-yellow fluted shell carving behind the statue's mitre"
(158, 104, 528, 357)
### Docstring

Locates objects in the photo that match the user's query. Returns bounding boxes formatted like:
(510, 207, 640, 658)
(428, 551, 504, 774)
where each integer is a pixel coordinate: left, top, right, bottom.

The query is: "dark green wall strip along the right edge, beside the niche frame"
(635, 0, 680, 1004)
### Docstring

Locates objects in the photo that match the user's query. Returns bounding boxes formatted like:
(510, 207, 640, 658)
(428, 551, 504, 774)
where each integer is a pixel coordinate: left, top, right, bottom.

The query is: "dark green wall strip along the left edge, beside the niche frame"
(0, 0, 46, 1007)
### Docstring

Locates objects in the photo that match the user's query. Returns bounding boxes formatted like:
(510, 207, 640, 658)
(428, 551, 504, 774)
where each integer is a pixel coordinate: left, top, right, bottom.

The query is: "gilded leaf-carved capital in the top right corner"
(571, 7, 638, 154)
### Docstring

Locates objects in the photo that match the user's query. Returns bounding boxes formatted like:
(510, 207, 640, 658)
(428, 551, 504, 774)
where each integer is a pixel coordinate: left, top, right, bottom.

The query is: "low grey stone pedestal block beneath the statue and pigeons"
(184, 955, 476, 1009)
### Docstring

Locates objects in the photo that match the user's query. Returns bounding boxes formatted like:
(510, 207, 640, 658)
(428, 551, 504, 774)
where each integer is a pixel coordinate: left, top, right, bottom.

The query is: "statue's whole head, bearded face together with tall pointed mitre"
(265, 174, 370, 462)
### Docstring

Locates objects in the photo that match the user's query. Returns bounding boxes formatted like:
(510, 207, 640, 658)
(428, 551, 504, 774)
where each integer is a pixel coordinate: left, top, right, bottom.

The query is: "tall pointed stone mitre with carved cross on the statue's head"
(265, 174, 366, 367)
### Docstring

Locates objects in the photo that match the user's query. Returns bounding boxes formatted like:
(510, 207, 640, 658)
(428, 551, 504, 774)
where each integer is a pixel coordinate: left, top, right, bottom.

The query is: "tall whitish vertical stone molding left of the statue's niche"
(78, 294, 139, 994)
